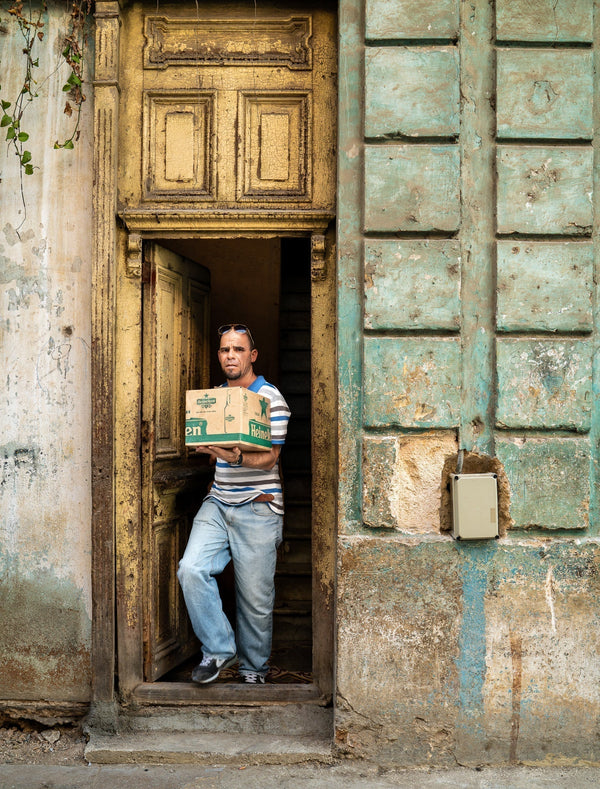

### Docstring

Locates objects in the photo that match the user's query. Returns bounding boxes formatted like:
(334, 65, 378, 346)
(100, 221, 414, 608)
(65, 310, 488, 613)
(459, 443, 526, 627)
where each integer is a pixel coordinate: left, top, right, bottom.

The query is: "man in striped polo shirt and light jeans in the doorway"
(177, 323, 290, 684)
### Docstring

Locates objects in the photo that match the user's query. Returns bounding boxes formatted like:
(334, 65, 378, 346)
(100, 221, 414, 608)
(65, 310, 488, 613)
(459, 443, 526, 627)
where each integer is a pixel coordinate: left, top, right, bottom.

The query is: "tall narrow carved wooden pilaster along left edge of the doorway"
(91, 0, 120, 702)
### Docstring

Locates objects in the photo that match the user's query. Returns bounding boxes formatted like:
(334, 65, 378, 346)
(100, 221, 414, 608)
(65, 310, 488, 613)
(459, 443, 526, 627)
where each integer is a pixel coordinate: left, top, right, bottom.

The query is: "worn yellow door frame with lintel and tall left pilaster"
(91, 0, 338, 705)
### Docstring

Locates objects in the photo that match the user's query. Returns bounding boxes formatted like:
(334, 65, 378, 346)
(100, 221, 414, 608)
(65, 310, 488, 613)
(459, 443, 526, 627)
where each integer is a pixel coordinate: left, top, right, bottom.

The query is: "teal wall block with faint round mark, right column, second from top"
(496, 49, 594, 139)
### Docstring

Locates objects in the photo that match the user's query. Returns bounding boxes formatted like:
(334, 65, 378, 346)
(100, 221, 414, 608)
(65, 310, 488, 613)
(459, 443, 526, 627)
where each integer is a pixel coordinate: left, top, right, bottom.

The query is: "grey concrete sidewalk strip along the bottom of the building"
(0, 761, 600, 789)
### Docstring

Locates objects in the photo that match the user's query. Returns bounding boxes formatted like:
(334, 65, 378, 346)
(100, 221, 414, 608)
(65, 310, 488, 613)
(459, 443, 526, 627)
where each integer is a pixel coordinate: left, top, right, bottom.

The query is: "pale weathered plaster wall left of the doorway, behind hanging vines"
(0, 6, 92, 701)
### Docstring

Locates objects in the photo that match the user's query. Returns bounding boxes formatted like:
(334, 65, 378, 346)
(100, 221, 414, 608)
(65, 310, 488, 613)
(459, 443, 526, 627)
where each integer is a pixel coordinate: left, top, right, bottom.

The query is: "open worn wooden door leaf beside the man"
(142, 244, 209, 681)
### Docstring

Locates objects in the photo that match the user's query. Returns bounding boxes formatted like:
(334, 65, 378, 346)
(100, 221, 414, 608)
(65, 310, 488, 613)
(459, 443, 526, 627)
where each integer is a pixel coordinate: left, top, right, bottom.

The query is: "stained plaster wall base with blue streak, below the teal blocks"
(336, 536, 600, 765)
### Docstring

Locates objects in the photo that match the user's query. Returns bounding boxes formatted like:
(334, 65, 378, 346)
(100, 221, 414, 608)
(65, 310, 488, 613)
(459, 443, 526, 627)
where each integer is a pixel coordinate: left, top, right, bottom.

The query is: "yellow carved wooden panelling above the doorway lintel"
(120, 2, 336, 223)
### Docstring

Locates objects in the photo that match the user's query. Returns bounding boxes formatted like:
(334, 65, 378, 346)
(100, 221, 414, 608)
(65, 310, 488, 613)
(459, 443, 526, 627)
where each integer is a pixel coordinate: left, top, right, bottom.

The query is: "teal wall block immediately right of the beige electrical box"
(496, 437, 591, 530)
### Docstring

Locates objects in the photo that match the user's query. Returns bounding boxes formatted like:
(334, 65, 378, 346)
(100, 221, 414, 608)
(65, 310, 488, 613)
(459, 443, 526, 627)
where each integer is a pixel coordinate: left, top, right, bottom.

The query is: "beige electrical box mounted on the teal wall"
(451, 474, 498, 540)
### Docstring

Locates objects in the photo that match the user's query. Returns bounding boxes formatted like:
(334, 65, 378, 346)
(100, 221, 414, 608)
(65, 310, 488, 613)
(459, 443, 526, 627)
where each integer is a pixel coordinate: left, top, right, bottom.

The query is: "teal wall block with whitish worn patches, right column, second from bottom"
(496, 338, 592, 431)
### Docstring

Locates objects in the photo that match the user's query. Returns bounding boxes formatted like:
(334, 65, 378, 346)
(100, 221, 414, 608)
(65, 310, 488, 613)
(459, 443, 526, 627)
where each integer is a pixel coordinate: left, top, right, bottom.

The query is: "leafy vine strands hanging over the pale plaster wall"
(0, 0, 92, 179)
